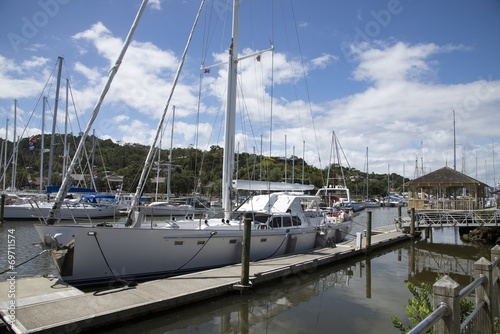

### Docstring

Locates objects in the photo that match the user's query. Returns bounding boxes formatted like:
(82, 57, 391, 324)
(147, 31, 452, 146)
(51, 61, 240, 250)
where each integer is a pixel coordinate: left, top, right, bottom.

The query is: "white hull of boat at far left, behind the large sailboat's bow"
(4, 203, 118, 220)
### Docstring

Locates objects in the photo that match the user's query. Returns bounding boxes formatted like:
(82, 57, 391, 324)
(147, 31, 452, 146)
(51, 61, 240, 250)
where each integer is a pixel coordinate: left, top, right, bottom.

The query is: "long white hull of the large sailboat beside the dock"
(35, 222, 351, 286)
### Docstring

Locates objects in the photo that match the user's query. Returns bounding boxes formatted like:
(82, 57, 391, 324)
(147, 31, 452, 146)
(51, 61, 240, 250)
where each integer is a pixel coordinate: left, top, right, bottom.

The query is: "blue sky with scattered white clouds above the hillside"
(0, 0, 500, 185)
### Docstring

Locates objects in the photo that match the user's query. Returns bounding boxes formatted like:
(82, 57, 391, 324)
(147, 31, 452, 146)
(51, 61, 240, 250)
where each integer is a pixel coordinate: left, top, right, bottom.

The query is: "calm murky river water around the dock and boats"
(0, 208, 492, 334)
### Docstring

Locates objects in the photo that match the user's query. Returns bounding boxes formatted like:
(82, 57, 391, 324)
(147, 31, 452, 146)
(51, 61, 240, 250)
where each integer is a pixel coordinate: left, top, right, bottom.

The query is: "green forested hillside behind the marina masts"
(2, 135, 403, 198)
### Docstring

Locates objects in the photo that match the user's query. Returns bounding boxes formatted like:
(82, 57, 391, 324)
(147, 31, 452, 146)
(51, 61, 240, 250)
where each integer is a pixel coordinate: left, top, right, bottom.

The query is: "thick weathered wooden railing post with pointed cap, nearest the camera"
(432, 275, 460, 334)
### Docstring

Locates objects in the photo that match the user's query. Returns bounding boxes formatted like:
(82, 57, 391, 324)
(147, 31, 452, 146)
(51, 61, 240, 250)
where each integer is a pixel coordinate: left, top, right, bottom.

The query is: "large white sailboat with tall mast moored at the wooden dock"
(35, 0, 351, 285)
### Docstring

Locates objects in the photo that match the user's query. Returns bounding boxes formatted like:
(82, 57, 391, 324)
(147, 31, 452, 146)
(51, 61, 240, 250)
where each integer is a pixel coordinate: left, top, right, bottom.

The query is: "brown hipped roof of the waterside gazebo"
(407, 166, 487, 187)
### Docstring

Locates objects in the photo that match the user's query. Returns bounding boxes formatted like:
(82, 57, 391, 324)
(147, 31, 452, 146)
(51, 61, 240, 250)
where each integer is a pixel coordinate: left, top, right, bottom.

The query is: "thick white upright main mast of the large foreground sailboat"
(222, 0, 240, 220)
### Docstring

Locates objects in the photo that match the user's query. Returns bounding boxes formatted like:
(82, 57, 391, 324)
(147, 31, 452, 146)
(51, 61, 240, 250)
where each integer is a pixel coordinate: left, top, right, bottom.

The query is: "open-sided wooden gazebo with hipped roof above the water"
(406, 167, 488, 211)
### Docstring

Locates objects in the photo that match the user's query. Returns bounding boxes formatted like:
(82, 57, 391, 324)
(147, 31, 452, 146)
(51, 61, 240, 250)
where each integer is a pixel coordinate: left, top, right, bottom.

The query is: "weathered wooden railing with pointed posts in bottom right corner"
(408, 245, 500, 334)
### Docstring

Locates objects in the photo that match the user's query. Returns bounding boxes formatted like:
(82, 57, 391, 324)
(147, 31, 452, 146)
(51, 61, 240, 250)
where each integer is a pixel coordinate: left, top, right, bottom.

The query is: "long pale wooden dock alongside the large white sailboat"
(0, 225, 410, 333)
